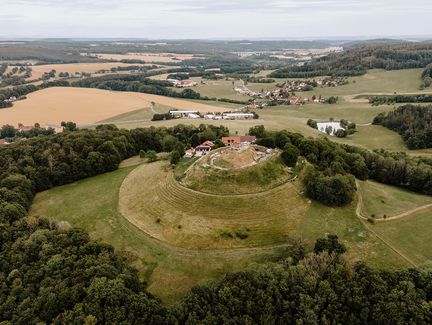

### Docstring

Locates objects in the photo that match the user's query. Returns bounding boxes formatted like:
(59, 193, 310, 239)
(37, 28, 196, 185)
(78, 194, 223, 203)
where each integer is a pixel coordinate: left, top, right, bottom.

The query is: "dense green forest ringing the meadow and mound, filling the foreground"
(0, 123, 432, 325)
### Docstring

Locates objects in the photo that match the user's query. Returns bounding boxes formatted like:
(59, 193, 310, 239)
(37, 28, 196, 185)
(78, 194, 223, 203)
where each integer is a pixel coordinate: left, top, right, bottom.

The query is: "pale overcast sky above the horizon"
(0, 0, 432, 39)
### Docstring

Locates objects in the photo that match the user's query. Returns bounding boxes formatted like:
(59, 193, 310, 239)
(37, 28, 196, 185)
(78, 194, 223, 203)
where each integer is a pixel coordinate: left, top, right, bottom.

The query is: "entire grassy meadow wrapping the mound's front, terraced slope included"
(30, 158, 408, 303)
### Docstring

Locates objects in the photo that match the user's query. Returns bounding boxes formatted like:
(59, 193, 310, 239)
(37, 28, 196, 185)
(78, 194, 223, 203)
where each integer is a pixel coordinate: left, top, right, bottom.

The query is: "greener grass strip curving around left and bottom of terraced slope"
(30, 165, 286, 304)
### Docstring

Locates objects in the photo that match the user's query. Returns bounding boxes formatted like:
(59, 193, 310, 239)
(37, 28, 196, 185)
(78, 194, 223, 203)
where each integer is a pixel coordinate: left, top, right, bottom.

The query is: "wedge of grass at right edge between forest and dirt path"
(360, 181, 432, 218)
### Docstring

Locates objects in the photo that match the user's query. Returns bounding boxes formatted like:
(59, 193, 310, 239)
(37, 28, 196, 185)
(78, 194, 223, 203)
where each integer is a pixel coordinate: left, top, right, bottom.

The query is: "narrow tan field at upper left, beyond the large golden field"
(25, 62, 150, 79)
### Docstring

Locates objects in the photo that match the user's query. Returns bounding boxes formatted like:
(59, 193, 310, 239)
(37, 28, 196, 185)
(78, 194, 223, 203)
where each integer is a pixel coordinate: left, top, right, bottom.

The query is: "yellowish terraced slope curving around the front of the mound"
(119, 162, 309, 249)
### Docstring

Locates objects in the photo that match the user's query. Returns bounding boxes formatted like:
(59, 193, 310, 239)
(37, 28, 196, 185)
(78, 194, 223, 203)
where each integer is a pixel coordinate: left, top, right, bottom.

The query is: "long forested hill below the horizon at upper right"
(270, 42, 432, 78)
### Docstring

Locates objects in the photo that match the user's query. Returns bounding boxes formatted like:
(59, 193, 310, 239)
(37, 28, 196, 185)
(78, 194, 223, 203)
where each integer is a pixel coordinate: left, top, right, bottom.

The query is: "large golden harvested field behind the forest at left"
(0, 87, 226, 125)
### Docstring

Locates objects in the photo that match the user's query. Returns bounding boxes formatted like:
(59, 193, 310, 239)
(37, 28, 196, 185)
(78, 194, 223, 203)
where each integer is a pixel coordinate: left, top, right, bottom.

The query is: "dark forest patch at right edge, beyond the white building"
(373, 105, 432, 149)
